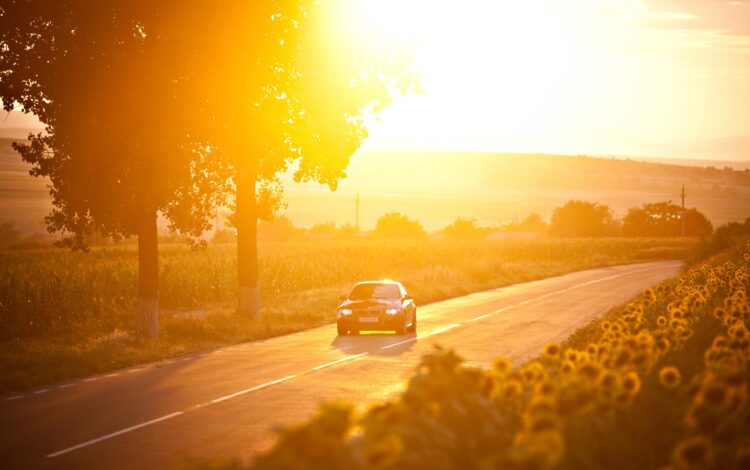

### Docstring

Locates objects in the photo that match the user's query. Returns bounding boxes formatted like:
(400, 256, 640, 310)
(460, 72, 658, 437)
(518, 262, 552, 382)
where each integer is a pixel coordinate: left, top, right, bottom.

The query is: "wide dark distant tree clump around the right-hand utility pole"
(622, 201, 713, 237)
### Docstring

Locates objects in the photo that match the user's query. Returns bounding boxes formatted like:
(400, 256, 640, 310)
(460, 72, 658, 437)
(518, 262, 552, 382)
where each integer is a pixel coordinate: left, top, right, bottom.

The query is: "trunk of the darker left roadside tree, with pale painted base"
(138, 213, 159, 338)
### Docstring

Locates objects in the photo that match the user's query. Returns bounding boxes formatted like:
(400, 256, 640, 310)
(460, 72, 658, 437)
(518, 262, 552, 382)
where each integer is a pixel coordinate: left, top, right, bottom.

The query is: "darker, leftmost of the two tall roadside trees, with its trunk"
(0, 0, 231, 336)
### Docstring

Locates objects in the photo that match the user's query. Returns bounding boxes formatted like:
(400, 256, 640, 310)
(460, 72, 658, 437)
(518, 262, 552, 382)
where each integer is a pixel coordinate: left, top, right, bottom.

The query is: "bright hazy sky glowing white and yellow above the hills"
(0, 0, 750, 159)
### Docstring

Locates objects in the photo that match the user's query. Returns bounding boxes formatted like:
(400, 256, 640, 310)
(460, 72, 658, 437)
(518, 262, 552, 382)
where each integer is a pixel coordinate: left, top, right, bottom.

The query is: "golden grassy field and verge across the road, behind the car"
(0, 239, 693, 393)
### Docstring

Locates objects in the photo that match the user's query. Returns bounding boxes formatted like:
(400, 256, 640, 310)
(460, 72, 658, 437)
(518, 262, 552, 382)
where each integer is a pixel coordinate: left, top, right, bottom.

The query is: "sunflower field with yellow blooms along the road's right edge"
(245, 243, 750, 469)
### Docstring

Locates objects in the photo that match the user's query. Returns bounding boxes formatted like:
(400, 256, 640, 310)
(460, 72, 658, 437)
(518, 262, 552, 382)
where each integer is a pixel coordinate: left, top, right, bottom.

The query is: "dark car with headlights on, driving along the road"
(336, 281, 417, 336)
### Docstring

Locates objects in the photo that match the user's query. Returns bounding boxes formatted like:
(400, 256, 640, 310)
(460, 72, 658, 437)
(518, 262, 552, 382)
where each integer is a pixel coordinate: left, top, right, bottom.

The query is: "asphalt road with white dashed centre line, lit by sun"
(0, 261, 680, 469)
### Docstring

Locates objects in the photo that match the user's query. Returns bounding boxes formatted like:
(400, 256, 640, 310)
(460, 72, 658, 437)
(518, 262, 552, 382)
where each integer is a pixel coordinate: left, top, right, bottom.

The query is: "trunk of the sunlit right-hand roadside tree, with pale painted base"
(235, 172, 260, 318)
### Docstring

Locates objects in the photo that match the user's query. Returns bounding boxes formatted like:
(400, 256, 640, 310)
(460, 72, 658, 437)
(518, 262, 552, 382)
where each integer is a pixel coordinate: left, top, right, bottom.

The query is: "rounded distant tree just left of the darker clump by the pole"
(549, 200, 616, 237)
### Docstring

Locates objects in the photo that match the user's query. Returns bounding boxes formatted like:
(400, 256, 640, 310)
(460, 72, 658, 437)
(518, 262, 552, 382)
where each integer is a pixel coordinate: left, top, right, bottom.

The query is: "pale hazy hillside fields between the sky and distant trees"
(0, 138, 750, 231)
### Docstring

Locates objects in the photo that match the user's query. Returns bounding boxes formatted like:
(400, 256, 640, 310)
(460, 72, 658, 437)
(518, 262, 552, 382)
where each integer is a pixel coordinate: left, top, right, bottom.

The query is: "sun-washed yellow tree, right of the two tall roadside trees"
(188, 0, 416, 315)
